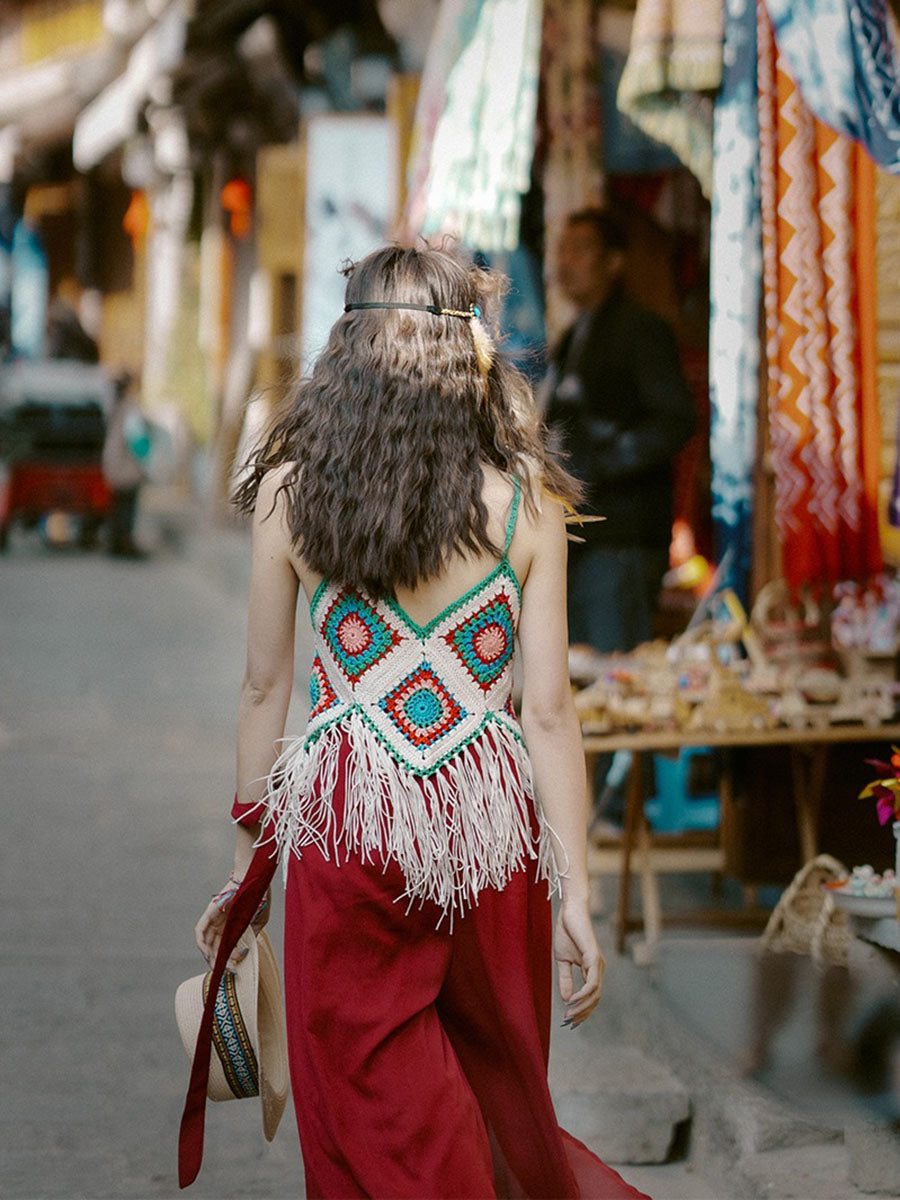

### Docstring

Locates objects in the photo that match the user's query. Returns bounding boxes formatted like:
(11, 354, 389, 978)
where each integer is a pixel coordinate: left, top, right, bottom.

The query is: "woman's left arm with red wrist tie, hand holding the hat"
(194, 472, 299, 965)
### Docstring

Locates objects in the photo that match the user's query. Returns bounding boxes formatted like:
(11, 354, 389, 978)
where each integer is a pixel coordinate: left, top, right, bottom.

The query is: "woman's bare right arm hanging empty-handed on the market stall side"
(518, 497, 604, 1025)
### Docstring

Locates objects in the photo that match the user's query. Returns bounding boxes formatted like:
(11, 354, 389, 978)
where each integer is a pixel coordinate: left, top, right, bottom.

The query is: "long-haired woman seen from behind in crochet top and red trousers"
(181, 247, 641, 1200)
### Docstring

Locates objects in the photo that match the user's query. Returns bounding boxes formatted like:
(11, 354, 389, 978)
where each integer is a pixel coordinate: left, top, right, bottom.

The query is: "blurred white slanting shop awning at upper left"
(72, 0, 187, 170)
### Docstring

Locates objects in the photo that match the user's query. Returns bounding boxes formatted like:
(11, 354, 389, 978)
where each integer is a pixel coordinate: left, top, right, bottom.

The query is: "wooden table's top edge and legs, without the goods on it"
(584, 722, 900, 960)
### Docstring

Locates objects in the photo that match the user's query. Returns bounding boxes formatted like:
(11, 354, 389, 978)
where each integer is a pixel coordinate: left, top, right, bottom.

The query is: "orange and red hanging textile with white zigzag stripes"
(758, 0, 882, 588)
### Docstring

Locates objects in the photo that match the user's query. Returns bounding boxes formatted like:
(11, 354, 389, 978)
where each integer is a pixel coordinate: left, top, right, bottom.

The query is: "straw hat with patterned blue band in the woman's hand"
(175, 929, 288, 1141)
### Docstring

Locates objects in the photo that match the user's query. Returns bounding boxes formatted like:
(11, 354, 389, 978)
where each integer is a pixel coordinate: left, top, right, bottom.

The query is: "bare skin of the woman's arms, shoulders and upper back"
(194, 468, 605, 1026)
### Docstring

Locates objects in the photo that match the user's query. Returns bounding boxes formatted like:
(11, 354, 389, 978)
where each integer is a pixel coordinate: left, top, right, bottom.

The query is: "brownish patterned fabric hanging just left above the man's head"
(540, 0, 604, 340)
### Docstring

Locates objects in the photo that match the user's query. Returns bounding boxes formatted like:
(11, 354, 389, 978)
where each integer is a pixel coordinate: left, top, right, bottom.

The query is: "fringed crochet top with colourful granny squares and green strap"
(256, 480, 557, 919)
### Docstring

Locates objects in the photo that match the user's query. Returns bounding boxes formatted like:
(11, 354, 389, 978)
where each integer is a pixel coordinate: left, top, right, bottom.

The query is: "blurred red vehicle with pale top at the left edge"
(0, 359, 114, 551)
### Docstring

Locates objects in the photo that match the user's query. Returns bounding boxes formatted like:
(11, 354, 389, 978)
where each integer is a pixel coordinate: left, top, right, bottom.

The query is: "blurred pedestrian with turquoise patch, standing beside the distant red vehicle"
(103, 371, 150, 558)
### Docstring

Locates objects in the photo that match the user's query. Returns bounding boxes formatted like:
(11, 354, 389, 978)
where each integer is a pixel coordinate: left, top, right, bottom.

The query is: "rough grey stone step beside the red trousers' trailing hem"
(550, 1031, 691, 1163)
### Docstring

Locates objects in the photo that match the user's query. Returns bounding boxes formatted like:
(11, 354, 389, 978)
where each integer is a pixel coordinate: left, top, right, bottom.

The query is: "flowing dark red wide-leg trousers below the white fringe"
(284, 792, 643, 1200)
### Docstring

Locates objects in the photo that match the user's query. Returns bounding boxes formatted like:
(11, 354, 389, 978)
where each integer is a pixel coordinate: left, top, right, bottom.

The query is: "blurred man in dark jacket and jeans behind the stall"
(544, 209, 695, 653)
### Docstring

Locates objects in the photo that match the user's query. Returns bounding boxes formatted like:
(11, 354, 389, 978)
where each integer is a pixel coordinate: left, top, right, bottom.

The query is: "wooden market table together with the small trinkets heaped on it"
(570, 577, 900, 954)
